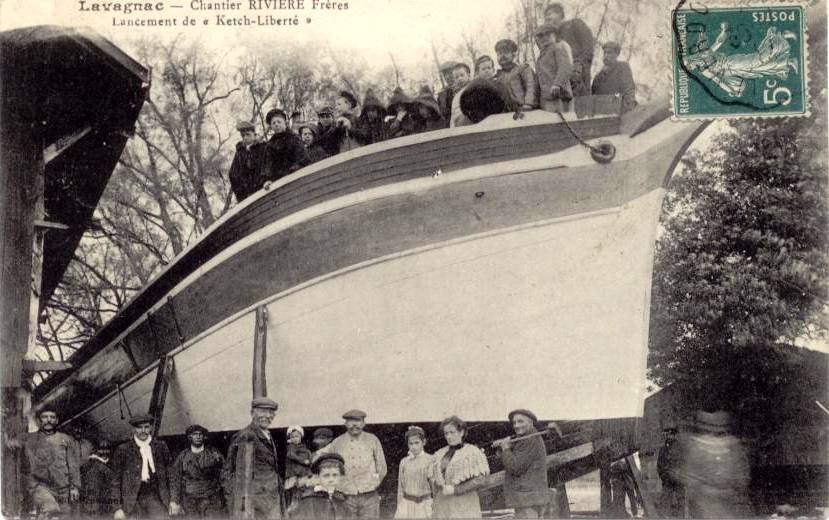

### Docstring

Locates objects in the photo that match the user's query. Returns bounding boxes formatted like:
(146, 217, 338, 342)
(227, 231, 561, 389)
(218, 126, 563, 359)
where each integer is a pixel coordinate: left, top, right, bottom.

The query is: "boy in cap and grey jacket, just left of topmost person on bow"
(535, 23, 573, 112)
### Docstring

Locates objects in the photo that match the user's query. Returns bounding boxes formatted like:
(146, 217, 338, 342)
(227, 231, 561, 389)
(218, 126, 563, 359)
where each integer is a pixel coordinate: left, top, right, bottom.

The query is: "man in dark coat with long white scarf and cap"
(111, 415, 172, 520)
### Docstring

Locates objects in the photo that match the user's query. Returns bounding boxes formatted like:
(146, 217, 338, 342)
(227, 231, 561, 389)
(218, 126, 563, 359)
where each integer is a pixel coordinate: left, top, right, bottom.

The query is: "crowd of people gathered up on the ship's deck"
(229, 3, 636, 205)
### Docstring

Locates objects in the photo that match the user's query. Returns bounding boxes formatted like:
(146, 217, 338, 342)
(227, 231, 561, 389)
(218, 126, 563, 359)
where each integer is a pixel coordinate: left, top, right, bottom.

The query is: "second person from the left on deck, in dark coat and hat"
(262, 108, 311, 187)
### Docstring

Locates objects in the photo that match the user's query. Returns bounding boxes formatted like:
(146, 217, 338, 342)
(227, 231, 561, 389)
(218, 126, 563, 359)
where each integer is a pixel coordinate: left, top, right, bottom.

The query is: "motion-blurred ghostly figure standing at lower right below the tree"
(679, 410, 752, 518)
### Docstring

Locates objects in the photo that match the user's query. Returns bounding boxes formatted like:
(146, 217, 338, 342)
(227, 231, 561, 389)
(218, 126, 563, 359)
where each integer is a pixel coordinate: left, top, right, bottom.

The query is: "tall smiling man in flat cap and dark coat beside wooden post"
(222, 397, 284, 518)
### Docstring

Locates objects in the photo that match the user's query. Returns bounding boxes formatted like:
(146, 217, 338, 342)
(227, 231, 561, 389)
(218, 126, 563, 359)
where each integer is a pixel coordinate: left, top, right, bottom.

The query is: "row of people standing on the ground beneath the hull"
(25, 404, 551, 520)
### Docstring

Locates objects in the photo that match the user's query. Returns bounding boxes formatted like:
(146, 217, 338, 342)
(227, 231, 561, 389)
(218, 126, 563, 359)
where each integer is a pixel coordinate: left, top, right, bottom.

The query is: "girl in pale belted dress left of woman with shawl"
(394, 426, 432, 518)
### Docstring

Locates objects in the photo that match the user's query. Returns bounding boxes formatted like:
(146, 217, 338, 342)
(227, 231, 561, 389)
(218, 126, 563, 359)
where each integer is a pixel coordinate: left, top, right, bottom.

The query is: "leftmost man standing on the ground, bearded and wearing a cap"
(24, 407, 81, 518)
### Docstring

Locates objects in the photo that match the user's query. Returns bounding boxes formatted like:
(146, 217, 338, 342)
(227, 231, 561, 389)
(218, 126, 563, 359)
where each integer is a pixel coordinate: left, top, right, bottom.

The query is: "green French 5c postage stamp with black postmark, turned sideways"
(671, 1, 809, 119)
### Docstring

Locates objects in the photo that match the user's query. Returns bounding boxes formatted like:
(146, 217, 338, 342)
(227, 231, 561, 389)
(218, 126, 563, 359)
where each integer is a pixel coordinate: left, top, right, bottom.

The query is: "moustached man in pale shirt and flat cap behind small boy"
(314, 410, 387, 518)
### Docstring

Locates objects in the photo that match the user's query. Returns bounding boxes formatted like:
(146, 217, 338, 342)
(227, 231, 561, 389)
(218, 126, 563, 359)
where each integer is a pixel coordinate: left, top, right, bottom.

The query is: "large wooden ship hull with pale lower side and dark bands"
(35, 104, 702, 440)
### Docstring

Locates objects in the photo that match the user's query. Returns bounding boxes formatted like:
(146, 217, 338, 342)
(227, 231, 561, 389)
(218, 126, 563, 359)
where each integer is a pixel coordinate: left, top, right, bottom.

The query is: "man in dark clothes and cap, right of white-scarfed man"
(170, 424, 225, 518)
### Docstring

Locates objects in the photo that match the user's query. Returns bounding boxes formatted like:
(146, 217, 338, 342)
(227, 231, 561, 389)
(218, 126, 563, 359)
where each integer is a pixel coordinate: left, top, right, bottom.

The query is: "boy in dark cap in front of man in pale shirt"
(292, 453, 351, 520)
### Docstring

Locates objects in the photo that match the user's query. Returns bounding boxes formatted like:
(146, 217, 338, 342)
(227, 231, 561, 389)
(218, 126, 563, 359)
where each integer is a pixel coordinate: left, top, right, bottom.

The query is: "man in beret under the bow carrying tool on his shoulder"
(497, 410, 550, 518)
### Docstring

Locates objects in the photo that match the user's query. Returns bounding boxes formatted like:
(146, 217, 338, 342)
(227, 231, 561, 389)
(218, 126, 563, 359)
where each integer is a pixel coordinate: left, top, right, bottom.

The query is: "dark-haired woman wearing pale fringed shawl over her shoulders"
(429, 415, 489, 518)
